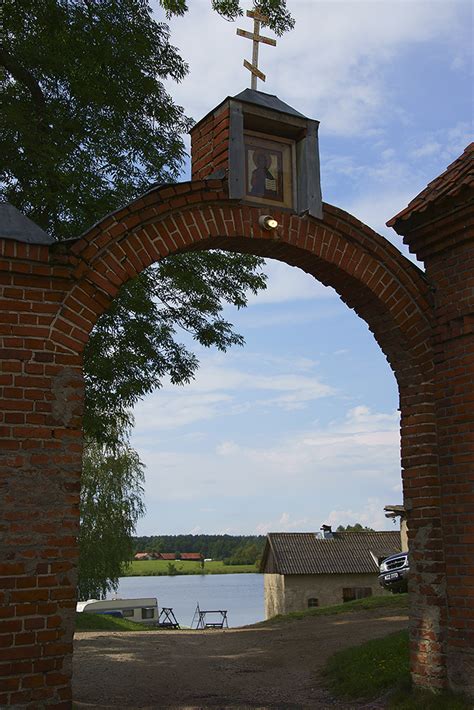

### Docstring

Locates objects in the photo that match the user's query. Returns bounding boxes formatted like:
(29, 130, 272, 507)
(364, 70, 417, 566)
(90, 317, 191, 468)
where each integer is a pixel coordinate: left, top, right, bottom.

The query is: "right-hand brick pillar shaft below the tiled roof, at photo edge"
(426, 241, 474, 696)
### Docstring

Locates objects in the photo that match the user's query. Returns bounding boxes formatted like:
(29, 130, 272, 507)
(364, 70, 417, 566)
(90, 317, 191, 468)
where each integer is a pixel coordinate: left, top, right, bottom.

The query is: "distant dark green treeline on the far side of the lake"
(133, 535, 266, 565)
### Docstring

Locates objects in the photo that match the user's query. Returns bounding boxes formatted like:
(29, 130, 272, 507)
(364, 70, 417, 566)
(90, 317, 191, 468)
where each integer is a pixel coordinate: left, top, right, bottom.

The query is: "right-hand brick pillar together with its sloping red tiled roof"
(389, 144, 474, 696)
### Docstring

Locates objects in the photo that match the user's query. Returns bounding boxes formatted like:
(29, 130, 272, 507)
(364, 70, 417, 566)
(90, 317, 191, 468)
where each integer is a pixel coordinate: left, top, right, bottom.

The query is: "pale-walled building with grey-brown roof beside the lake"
(260, 525, 400, 619)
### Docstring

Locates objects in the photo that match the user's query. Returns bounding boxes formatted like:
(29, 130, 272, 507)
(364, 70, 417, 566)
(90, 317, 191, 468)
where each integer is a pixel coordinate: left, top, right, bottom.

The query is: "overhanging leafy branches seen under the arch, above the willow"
(84, 251, 265, 445)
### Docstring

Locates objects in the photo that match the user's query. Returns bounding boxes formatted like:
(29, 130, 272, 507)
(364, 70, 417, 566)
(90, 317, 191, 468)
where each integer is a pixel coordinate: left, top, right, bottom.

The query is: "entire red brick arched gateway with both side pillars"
(0, 86, 474, 708)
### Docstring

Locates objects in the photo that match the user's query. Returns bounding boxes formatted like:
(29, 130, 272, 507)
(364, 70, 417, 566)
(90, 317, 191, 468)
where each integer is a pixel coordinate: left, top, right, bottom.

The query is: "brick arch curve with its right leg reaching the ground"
(51, 180, 446, 687)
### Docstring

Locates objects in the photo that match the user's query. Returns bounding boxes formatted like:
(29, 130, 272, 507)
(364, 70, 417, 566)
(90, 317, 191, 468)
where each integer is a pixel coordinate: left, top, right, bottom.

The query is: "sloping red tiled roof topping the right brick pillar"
(387, 143, 474, 227)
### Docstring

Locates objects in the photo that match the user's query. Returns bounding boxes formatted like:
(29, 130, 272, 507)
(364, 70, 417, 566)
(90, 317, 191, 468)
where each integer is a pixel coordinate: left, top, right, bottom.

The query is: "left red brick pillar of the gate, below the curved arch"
(0, 239, 83, 708)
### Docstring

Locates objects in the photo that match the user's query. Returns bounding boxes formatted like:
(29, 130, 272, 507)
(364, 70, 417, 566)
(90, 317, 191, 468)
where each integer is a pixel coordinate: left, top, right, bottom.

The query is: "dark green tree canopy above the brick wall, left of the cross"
(0, 0, 293, 239)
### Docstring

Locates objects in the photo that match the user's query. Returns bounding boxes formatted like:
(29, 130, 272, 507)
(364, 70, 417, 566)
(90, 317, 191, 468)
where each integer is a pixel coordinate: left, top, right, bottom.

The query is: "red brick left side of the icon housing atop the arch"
(191, 104, 230, 180)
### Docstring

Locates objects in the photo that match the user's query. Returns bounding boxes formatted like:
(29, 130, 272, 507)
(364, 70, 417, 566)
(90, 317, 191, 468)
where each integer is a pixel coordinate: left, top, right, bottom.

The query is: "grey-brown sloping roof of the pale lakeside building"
(262, 530, 400, 574)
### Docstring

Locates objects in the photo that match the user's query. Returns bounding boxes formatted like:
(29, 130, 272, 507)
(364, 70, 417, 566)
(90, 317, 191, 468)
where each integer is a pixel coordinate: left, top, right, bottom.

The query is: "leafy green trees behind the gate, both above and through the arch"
(0, 0, 293, 597)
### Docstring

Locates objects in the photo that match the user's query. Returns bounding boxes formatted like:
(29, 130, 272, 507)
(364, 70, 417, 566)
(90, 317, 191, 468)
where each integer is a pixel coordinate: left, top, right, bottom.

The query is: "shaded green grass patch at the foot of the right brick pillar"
(323, 631, 472, 710)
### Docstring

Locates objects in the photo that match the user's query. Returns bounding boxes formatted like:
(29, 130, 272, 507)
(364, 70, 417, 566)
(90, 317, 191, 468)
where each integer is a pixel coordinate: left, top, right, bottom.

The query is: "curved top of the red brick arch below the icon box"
(51, 180, 432, 390)
